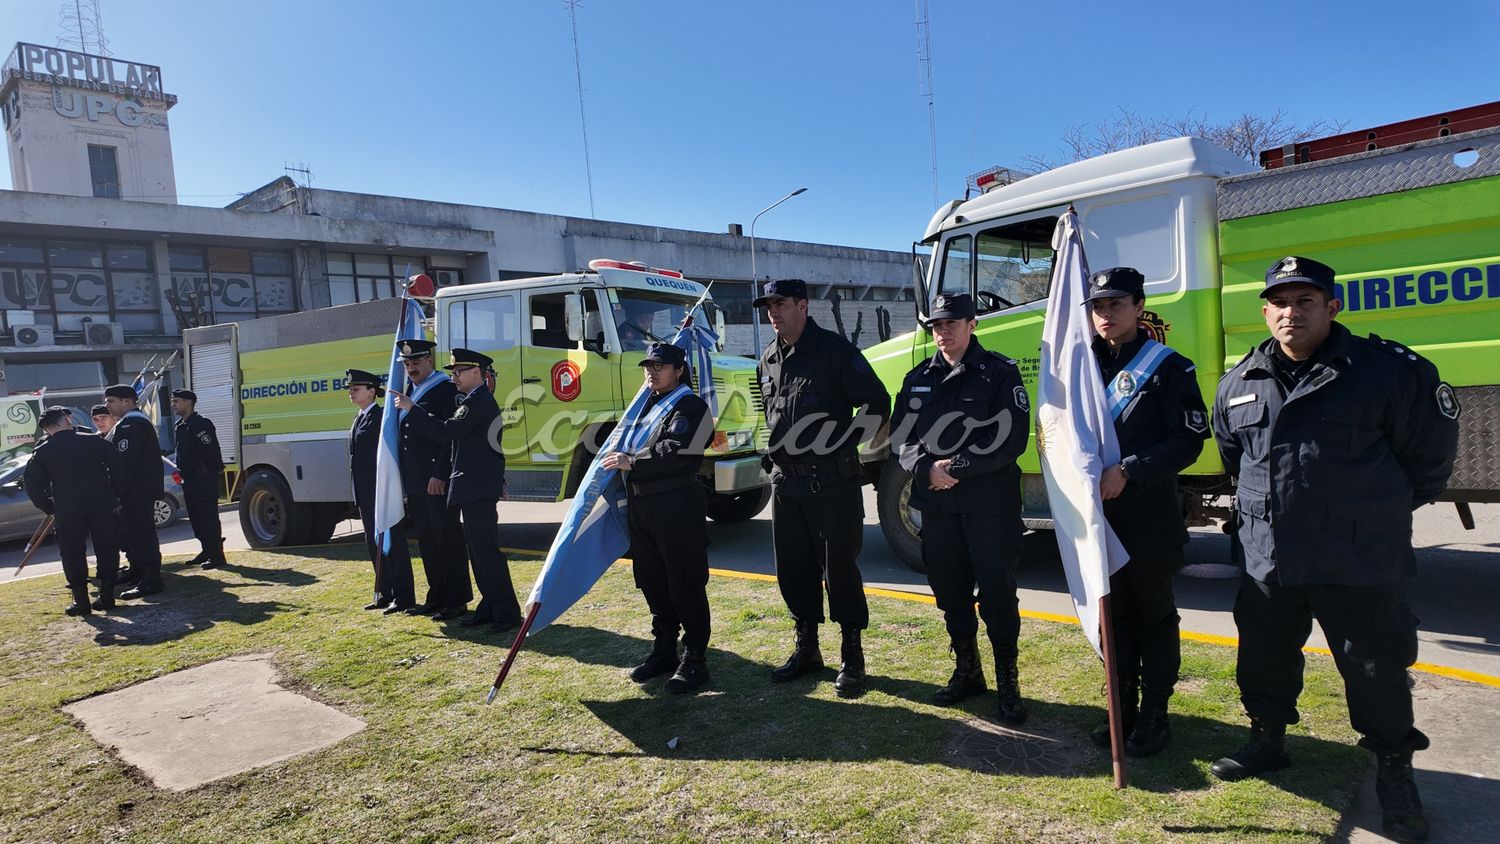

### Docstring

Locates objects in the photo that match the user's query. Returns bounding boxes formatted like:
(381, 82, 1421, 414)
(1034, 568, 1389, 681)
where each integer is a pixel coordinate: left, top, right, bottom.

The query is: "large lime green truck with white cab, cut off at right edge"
(864, 129, 1500, 570)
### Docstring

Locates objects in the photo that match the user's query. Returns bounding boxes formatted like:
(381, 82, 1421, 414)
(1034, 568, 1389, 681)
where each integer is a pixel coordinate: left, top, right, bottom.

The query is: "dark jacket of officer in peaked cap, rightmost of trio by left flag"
(404, 384, 506, 507)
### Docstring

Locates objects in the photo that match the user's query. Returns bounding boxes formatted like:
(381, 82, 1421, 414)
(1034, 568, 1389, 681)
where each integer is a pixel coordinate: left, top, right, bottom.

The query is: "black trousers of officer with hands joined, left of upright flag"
(923, 513, 1022, 651)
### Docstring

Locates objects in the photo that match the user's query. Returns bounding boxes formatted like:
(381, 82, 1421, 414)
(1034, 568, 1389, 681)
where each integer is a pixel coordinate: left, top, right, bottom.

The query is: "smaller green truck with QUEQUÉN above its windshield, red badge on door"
(183, 259, 771, 547)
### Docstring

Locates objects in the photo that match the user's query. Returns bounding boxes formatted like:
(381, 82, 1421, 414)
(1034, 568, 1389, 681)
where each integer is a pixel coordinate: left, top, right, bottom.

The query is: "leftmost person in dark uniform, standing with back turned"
(26, 408, 125, 616)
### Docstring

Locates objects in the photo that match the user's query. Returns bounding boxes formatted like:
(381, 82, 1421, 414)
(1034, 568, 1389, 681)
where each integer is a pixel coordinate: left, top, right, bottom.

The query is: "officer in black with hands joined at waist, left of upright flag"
(891, 294, 1031, 724)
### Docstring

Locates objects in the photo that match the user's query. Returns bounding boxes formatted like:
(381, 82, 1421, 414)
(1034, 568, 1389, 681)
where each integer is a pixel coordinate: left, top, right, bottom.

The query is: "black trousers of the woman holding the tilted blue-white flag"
(626, 480, 710, 651)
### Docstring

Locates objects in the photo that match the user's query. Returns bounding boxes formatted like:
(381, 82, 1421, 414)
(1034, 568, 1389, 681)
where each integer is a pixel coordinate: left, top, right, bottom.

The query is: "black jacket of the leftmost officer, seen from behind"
(24, 430, 126, 517)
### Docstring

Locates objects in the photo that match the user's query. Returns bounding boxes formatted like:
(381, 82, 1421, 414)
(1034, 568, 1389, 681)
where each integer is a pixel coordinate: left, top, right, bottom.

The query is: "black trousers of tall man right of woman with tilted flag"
(771, 484, 870, 630)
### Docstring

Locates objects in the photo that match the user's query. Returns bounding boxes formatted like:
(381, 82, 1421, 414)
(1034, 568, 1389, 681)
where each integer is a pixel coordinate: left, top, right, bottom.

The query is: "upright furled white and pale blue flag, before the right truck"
(1037, 208, 1130, 655)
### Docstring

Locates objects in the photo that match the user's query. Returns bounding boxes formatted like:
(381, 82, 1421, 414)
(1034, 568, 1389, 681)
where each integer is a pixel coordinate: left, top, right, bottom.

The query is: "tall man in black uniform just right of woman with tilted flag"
(752, 279, 891, 697)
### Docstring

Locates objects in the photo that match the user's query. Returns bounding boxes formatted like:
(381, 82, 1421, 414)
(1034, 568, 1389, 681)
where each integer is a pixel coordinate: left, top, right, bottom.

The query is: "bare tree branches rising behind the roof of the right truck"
(1026, 108, 1347, 169)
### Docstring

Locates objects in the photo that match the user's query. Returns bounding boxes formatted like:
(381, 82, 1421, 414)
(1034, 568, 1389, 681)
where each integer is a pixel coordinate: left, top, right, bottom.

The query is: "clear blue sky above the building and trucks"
(0, 0, 1500, 250)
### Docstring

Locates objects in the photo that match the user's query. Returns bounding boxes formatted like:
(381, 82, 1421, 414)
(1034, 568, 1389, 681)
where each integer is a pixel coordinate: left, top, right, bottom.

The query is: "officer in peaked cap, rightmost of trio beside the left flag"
(395, 349, 521, 630)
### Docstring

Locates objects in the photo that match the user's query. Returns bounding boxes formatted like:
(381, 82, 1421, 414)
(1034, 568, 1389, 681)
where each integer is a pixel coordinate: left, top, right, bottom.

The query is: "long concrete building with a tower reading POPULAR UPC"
(0, 43, 915, 405)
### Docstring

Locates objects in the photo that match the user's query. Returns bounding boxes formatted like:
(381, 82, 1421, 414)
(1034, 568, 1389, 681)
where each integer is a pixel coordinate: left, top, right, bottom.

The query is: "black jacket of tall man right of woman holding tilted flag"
(756, 318, 891, 495)
